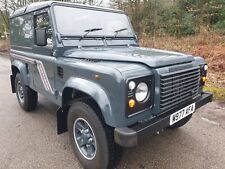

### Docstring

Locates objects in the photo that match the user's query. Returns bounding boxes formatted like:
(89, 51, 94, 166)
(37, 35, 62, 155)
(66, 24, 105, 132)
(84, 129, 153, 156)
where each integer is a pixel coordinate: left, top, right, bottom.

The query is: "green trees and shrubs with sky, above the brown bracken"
(0, 0, 225, 38)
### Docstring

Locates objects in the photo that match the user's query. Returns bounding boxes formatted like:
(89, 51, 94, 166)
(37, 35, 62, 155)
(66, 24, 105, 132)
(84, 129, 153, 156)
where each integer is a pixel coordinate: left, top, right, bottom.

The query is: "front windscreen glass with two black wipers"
(54, 6, 134, 37)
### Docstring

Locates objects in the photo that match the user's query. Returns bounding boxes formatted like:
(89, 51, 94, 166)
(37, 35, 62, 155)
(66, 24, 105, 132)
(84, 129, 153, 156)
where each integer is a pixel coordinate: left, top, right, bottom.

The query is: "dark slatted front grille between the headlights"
(160, 68, 200, 112)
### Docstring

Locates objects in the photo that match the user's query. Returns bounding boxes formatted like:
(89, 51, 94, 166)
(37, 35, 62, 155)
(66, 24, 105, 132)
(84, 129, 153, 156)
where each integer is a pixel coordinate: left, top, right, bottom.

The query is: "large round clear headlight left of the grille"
(135, 82, 148, 102)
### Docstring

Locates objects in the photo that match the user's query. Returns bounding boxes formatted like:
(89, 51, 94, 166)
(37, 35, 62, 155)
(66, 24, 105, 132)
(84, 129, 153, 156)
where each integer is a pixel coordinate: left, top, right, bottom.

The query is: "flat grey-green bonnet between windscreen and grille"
(64, 47, 194, 68)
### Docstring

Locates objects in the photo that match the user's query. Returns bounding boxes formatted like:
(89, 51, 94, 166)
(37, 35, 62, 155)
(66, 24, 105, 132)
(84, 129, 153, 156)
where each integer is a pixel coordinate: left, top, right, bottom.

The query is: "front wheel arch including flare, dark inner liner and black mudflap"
(57, 78, 115, 134)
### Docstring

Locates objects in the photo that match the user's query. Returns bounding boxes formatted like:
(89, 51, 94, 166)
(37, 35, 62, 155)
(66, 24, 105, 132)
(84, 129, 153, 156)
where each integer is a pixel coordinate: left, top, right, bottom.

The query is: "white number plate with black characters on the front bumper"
(170, 103, 195, 125)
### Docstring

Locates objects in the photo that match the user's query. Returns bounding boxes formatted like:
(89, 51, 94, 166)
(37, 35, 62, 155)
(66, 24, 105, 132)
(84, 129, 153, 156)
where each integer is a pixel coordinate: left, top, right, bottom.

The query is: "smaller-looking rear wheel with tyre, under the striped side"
(15, 73, 38, 111)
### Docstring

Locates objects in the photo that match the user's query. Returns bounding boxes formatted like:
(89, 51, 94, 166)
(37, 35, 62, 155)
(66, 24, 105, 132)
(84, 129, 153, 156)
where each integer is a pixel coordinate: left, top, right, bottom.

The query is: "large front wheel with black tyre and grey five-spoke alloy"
(67, 101, 122, 169)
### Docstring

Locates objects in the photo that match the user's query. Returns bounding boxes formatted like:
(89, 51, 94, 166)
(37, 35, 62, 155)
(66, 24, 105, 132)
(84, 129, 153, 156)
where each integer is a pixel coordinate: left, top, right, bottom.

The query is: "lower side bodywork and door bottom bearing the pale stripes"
(10, 50, 56, 103)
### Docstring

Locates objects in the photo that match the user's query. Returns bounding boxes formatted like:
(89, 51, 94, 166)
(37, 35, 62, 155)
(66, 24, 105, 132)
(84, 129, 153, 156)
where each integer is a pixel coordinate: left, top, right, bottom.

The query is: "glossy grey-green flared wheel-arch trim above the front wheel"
(64, 77, 115, 126)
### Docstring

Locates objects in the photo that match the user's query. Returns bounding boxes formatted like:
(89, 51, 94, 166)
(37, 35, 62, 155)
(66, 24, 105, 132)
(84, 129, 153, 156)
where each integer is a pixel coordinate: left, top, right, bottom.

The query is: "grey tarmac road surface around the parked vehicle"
(0, 56, 225, 169)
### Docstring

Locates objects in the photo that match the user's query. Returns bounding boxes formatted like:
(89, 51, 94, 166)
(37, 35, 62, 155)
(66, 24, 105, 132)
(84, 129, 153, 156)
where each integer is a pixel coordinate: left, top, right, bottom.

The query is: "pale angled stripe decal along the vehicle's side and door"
(11, 54, 54, 94)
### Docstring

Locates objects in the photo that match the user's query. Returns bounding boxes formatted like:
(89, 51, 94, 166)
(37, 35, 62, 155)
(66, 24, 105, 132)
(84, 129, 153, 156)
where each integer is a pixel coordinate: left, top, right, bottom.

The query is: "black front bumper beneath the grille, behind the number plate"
(114, 93, 212, 147)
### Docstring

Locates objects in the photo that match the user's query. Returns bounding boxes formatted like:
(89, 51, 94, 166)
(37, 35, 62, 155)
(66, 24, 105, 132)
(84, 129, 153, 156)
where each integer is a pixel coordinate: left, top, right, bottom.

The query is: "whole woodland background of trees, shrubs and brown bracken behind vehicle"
(0, 0, 225, 100)
